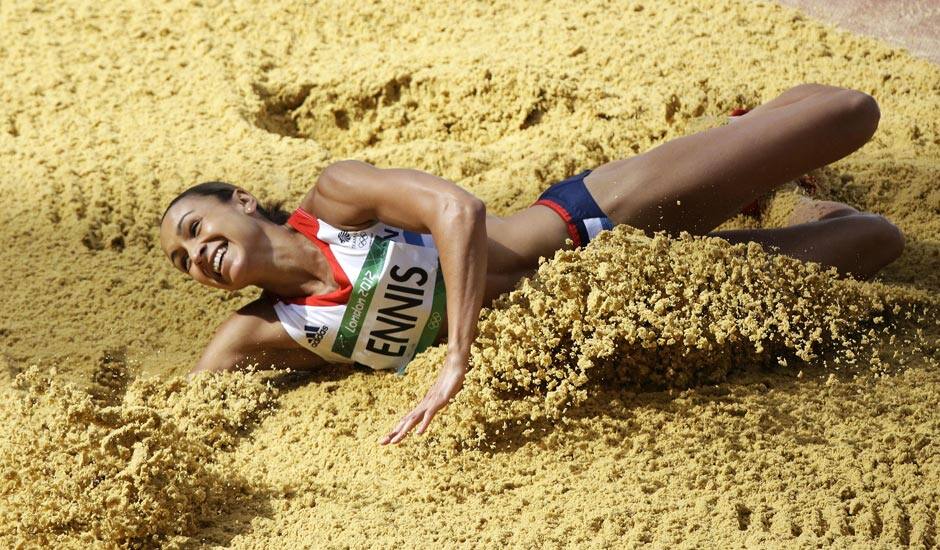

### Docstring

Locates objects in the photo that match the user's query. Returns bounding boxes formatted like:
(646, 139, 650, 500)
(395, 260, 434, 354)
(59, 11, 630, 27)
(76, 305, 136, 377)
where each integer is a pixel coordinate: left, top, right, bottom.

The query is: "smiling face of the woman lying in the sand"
(160, 190, 269, 290)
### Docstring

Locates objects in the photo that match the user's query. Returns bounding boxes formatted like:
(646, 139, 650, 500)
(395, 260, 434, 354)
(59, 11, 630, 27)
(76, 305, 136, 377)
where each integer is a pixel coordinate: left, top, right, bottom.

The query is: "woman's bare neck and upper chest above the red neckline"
(257, 224, 335, 298)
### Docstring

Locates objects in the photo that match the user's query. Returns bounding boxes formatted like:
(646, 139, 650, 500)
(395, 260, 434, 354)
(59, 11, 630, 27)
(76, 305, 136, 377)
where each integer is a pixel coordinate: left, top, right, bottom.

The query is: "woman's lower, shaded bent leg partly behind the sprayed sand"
(709, 212, 904, 279)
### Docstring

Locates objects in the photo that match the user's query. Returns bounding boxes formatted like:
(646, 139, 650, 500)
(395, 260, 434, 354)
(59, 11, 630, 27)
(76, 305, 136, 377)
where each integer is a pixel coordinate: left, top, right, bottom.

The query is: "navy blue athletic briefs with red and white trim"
(534, 170, 614, 246)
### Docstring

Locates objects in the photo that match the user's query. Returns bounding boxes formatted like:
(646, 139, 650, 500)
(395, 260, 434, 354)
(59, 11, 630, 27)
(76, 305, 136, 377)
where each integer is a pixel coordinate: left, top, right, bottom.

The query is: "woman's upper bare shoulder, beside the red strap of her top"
(300, 160, 382, 230)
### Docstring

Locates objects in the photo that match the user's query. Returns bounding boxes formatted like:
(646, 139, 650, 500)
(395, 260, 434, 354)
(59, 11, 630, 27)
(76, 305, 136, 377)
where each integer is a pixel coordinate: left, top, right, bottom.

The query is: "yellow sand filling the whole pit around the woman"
(0, 0, 940, 548)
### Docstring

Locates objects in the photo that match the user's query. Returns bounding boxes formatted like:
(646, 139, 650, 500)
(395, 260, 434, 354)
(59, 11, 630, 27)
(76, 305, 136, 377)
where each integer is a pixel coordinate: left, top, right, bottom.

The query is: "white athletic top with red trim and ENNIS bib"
(274, 208, 445, 374)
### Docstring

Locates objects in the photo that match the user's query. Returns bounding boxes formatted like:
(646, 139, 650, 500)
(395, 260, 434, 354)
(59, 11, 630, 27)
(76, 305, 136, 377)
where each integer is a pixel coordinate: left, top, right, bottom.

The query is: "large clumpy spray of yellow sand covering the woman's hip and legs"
(410, 226, 936, 452)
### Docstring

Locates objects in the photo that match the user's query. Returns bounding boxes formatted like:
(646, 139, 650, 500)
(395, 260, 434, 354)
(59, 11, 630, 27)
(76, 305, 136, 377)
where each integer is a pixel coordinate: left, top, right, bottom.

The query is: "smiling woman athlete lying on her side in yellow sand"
(160, 84, 904, 444)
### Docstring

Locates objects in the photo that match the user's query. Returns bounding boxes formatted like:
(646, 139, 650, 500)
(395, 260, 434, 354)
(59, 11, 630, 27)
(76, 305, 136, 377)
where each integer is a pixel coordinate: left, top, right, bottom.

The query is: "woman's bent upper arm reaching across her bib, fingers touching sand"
(302, 160, 487, 445)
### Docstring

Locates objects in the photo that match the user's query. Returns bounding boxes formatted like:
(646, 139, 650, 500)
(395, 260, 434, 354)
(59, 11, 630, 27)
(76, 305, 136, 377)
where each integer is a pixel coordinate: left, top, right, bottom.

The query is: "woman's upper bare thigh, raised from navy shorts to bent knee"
(585, 90, 878, 235)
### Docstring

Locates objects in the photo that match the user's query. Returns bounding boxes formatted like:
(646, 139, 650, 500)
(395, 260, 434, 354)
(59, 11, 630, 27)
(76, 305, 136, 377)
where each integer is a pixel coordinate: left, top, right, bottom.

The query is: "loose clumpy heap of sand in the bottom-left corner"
(0, 367, 274, 546)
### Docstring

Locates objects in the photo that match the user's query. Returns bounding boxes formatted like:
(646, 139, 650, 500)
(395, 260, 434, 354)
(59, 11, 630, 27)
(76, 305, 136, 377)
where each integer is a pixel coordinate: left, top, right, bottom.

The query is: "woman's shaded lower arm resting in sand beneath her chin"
(189, 298, 325, 376)
